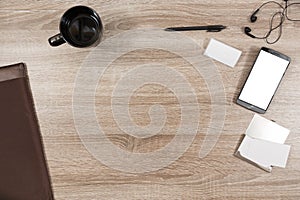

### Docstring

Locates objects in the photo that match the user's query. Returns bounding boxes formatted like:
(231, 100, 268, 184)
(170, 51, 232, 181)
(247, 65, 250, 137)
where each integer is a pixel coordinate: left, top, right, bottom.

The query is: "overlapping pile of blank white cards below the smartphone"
(236, 114, 290, 172)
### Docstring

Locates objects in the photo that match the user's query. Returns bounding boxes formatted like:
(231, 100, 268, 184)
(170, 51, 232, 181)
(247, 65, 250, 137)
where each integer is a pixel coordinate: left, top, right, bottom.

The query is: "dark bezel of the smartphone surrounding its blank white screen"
(236, 47, 291, 114)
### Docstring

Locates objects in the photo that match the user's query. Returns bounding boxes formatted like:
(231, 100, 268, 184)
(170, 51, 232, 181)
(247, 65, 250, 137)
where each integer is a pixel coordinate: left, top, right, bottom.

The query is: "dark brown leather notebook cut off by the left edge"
(0, 63, 54, 200)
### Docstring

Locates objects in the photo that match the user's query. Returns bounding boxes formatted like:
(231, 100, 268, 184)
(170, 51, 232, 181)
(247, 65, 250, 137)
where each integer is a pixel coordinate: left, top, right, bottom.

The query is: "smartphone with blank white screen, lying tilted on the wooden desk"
(237, 47, 291, 114)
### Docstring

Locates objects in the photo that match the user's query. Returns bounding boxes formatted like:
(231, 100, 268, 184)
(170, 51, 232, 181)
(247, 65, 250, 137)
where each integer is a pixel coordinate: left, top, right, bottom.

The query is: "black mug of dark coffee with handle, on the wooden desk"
(48, 6, 103, 47)
